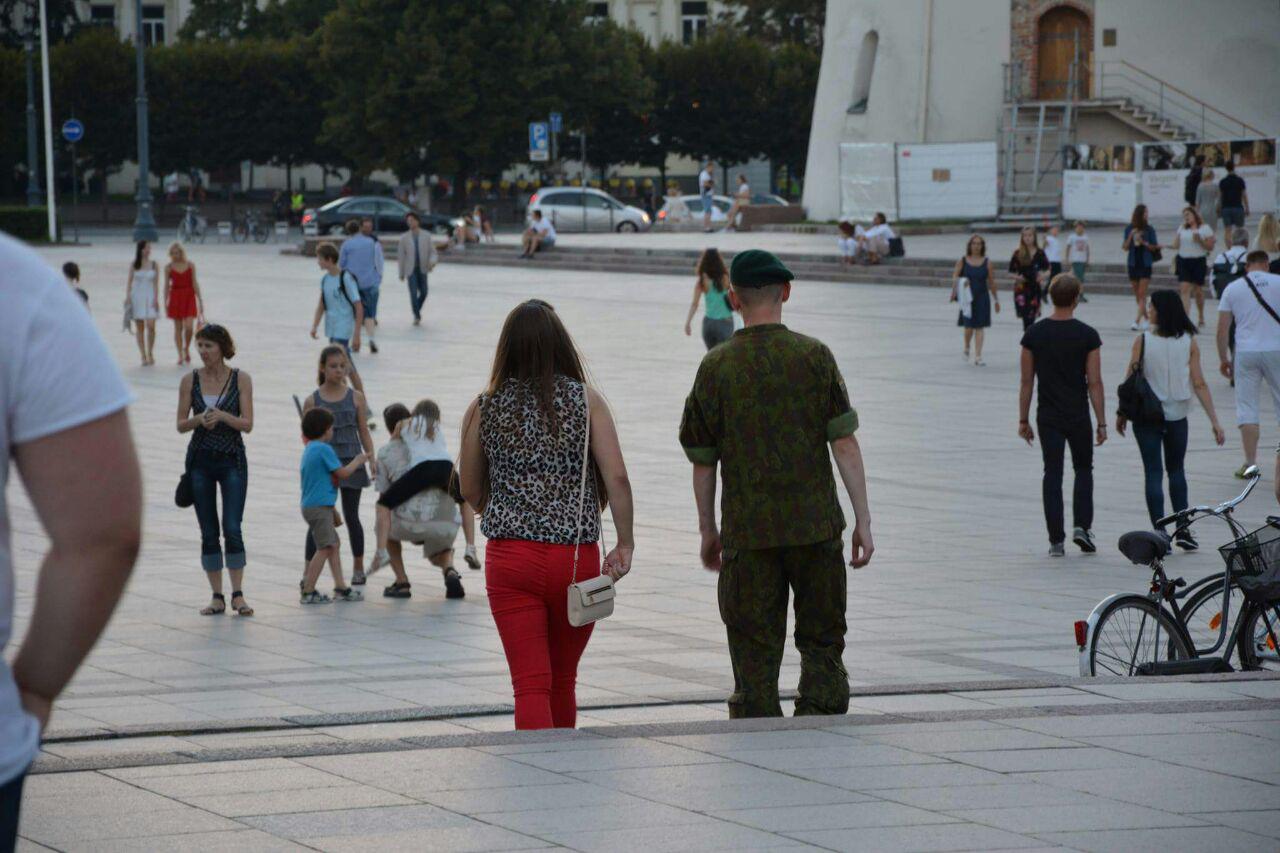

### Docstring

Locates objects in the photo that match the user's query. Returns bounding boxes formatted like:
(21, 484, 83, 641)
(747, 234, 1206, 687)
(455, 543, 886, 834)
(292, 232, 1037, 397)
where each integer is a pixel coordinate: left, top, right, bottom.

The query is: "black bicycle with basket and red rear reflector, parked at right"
(1075, 465, 1280, 676)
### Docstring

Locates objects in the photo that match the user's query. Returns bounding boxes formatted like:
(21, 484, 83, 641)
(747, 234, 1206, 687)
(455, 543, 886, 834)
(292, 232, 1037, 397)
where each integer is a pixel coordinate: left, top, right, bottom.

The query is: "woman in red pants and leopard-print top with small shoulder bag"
(460, 300, 634, 729)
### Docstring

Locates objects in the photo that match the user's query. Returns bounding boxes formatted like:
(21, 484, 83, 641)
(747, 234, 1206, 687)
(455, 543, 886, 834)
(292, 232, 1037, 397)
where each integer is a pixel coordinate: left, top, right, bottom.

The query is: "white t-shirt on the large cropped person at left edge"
(0, 234, 132, 784)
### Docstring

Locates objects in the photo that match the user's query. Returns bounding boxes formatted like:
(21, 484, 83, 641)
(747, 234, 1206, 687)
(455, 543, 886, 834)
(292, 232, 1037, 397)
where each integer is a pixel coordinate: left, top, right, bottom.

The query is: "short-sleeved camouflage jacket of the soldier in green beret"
(680, 324, 858, 548)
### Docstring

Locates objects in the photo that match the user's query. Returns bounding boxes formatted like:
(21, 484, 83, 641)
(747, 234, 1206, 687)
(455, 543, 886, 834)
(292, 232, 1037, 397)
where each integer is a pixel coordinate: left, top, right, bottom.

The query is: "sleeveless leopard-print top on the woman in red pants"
(480, 377, 600, 544)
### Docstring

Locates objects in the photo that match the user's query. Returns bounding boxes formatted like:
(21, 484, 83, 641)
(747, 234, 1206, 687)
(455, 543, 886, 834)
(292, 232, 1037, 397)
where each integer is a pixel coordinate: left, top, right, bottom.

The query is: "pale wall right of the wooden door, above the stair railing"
(1093, 0, 1280, 134)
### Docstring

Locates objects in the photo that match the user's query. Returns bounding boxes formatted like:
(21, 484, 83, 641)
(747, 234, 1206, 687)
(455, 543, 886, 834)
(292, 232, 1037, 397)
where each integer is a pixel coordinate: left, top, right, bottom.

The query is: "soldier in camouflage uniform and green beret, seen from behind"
(680, 250, 873, 719)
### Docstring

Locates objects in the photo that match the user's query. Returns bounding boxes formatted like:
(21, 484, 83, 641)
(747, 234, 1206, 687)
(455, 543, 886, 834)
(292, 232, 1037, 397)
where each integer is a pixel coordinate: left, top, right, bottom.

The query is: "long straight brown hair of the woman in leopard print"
(488, 300, 586, 432)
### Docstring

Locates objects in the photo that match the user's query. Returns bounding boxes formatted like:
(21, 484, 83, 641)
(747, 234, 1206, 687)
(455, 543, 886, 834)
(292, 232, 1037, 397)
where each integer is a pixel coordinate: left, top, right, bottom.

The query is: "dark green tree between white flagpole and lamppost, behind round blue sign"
(49, 27, 137, 219)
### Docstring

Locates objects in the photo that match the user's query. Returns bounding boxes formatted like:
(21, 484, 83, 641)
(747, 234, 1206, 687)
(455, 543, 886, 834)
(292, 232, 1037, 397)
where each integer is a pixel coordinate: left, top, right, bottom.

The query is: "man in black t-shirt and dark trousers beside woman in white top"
(1018, 273, 1107, 557)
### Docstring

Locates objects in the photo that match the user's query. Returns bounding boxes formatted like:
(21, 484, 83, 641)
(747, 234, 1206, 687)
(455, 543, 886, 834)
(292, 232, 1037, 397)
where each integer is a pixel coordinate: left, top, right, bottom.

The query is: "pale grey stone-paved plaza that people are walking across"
(9, 234, 1280, 850)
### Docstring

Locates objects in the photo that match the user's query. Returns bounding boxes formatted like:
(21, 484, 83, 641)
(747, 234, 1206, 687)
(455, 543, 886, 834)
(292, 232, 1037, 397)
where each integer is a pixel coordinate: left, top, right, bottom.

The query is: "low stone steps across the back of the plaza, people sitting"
(440, 245, 1157, 293)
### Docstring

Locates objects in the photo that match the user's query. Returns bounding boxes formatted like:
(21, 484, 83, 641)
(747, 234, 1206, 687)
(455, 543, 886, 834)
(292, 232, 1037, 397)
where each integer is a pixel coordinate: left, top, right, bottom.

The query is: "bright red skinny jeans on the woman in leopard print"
(485, 539, 600, 729)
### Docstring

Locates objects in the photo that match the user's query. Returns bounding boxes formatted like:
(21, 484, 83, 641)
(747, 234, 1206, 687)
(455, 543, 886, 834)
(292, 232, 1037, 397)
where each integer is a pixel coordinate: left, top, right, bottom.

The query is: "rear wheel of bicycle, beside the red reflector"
(1089, 596, 1192, 678)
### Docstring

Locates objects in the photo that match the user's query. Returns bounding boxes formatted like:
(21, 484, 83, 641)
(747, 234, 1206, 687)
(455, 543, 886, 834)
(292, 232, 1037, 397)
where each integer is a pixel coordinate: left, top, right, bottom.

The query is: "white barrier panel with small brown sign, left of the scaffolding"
(897, 141, 1000, 219)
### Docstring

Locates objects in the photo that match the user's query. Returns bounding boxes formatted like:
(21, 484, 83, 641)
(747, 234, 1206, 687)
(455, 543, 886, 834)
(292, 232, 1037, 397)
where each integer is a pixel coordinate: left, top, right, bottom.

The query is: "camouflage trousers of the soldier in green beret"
(718, 539, 849, 719)
